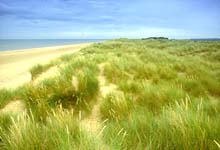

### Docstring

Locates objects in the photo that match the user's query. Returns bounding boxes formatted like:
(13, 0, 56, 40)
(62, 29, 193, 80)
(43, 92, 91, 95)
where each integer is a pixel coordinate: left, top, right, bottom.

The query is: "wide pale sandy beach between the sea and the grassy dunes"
(0, 43, 92, 88)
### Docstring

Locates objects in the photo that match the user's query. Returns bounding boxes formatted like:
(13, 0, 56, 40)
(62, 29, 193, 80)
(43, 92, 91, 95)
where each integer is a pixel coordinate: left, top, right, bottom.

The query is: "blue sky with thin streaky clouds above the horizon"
(0, 0, 220, 39)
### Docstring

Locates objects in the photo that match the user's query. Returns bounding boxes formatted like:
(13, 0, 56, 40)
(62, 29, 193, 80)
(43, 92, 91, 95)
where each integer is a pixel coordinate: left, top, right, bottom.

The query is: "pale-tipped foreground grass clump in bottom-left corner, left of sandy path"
(0, 109, 97, 150)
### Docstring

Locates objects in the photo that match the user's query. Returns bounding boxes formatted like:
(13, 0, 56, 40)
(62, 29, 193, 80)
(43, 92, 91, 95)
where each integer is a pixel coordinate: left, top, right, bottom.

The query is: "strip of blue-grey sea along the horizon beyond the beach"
(0, 39, 105, 51)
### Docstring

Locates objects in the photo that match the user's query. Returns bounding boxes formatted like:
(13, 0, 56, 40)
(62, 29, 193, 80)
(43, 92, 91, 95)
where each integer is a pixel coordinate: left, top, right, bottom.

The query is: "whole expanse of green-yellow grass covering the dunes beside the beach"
(0, 39, 220, 150)
